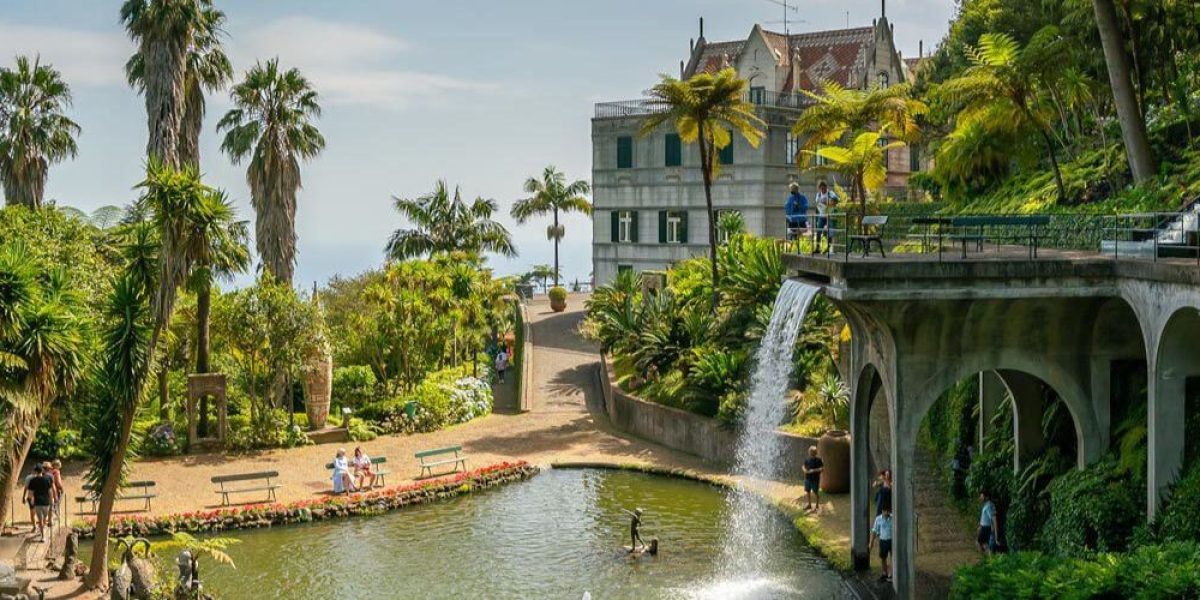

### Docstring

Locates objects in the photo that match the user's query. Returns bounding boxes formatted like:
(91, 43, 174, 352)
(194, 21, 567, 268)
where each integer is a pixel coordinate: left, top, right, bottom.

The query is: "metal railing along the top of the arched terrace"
(780, 211, 1200, 265)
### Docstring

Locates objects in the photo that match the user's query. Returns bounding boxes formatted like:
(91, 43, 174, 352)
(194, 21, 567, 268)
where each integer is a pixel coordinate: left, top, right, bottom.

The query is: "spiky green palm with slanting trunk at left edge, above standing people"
(0, 246, 86, 530)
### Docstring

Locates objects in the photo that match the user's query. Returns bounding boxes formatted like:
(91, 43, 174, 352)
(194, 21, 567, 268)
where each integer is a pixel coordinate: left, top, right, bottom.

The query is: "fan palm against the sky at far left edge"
(0, 56, 79, 209)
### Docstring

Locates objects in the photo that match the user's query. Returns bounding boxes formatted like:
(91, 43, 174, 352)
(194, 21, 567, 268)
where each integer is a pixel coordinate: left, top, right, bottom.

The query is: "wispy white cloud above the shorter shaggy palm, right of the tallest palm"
(230, 17, 496, 109)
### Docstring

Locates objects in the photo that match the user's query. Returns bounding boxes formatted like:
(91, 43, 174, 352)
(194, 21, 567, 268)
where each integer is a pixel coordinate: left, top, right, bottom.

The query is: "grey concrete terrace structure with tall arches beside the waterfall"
(785, 252, 1200, 598)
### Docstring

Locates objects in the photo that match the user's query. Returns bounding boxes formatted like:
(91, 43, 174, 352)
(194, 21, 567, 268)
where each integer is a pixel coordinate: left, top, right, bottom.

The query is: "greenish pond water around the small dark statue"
(103, 469, 850, 600)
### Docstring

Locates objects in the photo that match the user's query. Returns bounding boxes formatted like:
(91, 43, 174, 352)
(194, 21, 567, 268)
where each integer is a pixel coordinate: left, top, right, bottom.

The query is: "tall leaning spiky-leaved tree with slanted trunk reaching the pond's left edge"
(85, 158, 227, 588)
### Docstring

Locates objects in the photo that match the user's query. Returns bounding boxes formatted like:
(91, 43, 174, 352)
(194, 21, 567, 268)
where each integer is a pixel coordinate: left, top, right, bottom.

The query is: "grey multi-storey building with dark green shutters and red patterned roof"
(592, 10, 916, 286)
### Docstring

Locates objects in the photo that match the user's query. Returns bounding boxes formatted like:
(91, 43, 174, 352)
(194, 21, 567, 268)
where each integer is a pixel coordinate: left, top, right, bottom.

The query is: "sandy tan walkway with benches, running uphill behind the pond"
(2, 290, 974, 598)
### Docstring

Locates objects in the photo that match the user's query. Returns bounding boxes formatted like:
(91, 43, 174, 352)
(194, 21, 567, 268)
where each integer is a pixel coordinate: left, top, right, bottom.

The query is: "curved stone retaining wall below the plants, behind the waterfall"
(598, 354, 817, 478)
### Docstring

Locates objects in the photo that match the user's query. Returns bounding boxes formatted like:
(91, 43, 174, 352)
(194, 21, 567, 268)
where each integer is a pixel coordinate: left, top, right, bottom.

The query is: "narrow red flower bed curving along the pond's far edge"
(74, 461, 538, 539)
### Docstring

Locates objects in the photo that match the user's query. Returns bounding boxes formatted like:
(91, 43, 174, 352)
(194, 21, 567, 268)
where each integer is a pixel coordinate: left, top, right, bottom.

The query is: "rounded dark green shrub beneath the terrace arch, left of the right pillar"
(1043, 458, 1145, 556)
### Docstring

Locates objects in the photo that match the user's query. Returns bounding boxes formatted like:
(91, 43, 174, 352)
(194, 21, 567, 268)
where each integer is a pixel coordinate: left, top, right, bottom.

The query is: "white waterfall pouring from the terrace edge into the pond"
(721, 280, 820, 598)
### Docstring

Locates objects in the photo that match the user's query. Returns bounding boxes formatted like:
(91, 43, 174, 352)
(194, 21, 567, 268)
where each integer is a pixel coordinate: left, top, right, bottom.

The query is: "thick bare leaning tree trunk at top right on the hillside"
(1094, 0, 1156, 182)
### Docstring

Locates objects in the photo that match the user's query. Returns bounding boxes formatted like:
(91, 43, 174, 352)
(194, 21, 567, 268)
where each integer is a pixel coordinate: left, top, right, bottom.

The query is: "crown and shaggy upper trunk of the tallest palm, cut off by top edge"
(121, 0, 212, 167)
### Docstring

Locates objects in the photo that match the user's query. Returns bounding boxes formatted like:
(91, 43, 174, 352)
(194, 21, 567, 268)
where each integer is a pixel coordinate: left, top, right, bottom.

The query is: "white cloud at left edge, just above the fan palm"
(0, 20, 133, 86)
